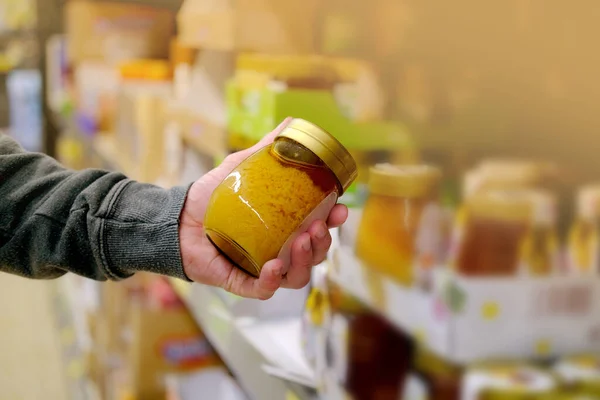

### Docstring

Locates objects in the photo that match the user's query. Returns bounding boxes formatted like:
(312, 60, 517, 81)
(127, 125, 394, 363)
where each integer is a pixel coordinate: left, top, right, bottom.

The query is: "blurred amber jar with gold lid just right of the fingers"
(356, 164, 441, 286)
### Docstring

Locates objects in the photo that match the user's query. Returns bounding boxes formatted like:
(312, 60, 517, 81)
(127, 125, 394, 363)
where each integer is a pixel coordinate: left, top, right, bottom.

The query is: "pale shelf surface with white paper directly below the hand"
(171, 280, 317, 400)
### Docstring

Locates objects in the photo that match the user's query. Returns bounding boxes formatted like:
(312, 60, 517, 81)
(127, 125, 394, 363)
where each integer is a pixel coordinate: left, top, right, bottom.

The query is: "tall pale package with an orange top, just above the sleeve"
(115, 60, 172, 182)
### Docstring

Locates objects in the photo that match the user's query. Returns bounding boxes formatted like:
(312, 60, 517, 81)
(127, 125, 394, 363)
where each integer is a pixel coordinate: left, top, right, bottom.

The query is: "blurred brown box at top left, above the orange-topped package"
(65, 0, 175, 63)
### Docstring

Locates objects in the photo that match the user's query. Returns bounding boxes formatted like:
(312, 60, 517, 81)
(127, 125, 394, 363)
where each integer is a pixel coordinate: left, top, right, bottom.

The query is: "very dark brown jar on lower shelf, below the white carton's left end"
(326, 281, 413, 400)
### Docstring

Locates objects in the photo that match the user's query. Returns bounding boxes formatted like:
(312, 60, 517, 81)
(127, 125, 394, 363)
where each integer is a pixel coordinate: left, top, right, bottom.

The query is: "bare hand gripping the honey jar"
(179, 118, 348, 300)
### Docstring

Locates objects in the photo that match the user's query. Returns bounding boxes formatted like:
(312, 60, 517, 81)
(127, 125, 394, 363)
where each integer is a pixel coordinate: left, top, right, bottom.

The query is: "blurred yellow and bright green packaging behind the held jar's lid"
(227, 54, 414, 153)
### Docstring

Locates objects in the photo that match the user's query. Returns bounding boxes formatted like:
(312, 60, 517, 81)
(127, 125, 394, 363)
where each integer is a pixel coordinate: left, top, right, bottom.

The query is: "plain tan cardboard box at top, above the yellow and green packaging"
(177, 0, 320, 53)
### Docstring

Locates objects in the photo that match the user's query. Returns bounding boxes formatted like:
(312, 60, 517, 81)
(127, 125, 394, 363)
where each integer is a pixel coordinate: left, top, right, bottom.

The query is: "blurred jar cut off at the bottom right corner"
(554, 354, 600, 398)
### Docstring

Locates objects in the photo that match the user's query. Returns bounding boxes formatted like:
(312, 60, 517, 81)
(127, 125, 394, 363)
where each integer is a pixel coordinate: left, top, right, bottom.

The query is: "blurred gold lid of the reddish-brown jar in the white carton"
(466, 190, 534, 222)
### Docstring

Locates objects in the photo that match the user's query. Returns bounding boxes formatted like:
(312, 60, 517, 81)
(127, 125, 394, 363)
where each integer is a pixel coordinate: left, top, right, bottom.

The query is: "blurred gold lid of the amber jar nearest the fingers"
(369, 164, 442, 197)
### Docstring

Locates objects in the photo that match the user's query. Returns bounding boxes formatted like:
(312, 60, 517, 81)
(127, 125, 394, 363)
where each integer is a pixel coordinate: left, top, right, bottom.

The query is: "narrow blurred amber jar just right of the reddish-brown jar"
(521, 190, 559, 276)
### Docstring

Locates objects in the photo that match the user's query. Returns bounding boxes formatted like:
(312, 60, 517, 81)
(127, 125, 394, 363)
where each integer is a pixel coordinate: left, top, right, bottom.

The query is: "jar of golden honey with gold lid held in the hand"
(204, 119, 357, 277)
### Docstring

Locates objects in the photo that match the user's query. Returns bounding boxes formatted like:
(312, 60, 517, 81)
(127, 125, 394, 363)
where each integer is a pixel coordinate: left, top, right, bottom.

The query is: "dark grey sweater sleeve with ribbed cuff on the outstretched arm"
(0, 134, 187, 280)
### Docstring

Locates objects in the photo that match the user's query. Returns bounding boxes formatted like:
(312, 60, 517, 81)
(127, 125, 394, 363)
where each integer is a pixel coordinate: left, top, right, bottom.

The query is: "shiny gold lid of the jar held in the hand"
(277, 118, 358, 191)
